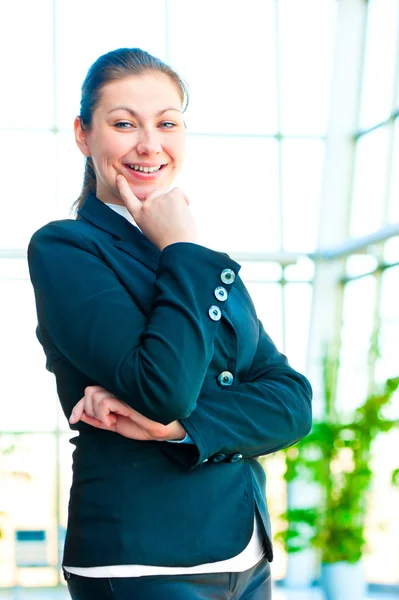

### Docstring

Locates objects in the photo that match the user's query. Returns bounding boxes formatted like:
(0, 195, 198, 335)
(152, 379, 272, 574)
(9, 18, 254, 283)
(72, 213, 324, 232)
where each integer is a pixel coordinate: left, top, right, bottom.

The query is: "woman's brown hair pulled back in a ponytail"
(72, 48, 188, 212)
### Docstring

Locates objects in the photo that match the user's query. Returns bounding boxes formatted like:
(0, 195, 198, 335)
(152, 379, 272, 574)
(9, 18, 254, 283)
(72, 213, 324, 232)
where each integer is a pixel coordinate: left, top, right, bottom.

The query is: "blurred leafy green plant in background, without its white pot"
(276, 359, 399, 563)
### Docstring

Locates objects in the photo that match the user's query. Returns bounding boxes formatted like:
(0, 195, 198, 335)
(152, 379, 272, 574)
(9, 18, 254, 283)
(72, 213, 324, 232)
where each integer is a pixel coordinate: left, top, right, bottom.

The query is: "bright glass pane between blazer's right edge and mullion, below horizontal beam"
(246, 283, 284, 352)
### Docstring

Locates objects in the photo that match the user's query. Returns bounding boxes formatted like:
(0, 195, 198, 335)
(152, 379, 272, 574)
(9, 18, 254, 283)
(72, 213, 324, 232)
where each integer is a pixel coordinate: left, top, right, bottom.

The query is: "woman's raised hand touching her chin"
(116, 174, 198, 251)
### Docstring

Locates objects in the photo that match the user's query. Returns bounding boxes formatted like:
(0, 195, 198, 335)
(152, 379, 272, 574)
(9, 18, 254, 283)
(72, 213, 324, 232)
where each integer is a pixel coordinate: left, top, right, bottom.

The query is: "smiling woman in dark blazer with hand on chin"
(28, 48, 311, 600)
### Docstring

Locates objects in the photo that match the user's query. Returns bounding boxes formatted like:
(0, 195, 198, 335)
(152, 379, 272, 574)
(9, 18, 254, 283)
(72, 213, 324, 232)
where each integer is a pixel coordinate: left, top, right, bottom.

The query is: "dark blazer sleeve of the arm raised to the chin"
(28, 221, 240, 424)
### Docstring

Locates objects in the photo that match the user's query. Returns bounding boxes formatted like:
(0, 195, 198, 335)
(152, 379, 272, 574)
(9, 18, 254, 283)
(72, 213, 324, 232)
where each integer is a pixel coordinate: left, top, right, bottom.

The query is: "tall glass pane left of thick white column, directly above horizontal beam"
(282, 140, 325, 252)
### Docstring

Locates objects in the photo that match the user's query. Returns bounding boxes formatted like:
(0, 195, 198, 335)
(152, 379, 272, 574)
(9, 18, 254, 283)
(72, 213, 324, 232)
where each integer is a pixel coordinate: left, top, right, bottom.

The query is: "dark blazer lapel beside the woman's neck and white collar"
(78, 193, 161, 271)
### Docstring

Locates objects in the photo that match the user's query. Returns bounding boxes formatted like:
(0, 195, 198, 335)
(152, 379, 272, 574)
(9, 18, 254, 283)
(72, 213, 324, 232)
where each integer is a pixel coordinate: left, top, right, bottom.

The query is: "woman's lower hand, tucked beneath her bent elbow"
(69, 385, 186, 442)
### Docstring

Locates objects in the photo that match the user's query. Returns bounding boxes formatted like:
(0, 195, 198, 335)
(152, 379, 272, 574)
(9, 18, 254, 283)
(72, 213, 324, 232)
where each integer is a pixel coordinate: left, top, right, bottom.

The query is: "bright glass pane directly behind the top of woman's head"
(55, 0, 165, 129)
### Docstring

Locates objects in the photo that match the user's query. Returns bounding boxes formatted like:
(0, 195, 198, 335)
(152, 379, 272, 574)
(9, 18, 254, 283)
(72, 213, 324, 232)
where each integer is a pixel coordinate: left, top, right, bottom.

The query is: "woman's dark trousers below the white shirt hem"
(64, 559, 271, 600)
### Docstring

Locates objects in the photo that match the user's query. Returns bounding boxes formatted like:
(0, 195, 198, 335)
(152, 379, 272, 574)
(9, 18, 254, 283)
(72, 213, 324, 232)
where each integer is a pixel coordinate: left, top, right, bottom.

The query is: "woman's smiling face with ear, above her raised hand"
(75, 72, 186, 204)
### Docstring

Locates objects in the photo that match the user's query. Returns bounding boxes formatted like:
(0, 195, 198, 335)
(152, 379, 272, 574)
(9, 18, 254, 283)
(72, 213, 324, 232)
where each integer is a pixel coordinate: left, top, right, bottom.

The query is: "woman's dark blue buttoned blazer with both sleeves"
(28, 195, 311, 567)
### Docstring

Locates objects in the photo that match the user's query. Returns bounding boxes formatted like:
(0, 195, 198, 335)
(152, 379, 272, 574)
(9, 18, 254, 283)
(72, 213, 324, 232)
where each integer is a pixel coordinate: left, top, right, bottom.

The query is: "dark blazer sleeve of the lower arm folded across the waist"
(163, 321, 312, 468)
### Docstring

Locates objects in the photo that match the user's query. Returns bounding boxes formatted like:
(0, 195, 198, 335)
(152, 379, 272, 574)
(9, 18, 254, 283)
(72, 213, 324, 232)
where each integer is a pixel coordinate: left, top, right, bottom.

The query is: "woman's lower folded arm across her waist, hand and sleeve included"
(69, 321, 312, 468)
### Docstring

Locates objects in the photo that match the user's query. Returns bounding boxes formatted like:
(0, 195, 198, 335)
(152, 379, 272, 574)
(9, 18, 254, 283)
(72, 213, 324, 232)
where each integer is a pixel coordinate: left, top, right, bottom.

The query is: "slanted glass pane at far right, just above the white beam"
(350, 127, 389, 237)
